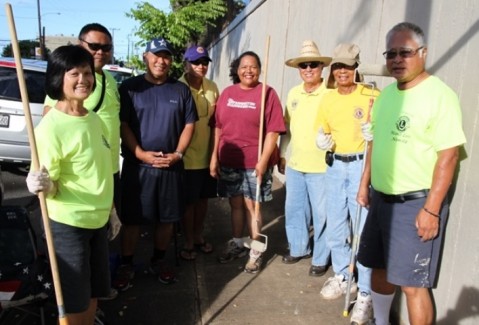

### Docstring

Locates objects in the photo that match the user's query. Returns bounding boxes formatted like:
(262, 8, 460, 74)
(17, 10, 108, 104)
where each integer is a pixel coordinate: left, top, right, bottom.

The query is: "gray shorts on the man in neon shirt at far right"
(358, 191, 449, 288)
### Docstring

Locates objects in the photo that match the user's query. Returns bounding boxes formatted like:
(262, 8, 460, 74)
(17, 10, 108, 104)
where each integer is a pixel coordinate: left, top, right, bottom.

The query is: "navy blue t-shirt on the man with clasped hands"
(120, 75, 198, 162)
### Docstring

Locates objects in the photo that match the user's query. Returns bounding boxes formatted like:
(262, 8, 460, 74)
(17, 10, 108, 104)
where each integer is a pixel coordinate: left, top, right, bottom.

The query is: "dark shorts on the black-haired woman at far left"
(50, 220, 110, 314)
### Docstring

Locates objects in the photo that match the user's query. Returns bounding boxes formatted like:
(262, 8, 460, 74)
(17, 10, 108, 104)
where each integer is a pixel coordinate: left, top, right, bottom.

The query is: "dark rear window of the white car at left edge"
(0, 67, 45, 103)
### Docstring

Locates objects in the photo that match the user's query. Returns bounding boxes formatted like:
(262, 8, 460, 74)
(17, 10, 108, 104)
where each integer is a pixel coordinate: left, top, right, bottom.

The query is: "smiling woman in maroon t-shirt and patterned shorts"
(210, 51, 286, 273)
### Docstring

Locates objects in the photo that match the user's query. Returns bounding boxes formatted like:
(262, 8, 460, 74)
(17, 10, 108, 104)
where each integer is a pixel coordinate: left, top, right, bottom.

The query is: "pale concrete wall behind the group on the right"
(210, 0, 479, 325)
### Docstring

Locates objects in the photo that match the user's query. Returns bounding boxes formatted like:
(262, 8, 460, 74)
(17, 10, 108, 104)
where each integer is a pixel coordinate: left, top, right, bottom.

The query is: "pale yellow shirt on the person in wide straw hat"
(284, 82, 330, 173)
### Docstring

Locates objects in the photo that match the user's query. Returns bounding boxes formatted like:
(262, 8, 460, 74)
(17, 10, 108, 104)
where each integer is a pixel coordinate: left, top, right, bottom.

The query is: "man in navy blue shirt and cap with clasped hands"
(113, 38, 198, 290)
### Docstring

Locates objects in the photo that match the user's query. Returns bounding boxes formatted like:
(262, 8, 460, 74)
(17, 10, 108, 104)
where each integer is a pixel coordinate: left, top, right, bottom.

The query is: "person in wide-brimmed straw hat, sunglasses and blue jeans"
(278, 40, 331, 276)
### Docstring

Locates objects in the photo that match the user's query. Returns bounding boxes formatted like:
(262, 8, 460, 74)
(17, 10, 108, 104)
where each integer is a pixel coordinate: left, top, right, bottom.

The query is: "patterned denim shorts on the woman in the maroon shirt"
(218, 167, 273, 202)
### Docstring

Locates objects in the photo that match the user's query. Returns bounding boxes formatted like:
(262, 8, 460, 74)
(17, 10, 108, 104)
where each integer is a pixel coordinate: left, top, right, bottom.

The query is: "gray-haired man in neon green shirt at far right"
(357, 22, 466, 325)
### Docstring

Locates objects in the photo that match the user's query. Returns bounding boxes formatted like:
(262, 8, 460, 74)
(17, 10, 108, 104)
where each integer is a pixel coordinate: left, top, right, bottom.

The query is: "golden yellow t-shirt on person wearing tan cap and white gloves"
(318, 85, 379, 154)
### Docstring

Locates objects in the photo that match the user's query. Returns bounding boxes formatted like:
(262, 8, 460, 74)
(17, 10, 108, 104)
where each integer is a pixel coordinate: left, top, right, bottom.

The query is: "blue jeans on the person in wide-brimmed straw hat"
(285, 167, 330, 266)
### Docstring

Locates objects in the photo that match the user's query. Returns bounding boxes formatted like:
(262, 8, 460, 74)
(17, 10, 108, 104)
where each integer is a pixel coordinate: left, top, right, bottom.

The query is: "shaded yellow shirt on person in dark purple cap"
(179, 75, 219, 169)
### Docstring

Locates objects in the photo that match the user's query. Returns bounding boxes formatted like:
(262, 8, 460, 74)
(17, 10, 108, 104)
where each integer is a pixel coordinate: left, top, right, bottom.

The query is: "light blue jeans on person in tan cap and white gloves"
(326, 160, 371, 293)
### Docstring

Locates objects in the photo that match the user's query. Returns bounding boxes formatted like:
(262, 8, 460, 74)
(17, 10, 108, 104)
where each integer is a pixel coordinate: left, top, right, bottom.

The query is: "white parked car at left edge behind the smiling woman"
(0, 58, 47, 165)
